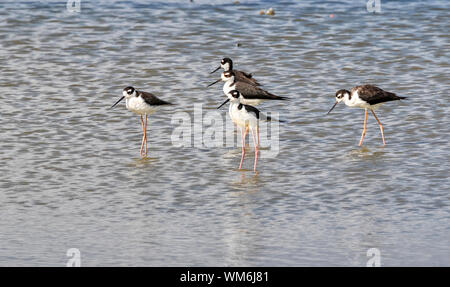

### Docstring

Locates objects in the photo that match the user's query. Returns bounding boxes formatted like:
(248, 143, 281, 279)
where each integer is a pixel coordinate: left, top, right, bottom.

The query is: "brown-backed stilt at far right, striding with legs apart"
(327, 85, 406, 146)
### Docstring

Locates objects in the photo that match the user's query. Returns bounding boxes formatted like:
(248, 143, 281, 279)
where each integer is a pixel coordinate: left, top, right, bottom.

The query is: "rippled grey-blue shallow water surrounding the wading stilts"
(0, 0, 450, 266)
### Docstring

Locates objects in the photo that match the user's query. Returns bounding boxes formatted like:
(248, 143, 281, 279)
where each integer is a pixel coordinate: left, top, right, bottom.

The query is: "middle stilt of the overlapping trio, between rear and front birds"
(208, 71, 287, 105)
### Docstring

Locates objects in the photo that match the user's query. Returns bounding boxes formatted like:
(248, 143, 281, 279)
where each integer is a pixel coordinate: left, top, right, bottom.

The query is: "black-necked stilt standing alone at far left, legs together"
(110, 87, 171, 157)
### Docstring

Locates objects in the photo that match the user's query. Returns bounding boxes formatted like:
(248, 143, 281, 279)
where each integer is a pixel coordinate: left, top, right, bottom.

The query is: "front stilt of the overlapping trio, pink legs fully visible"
(218, 90, 278, 172)
